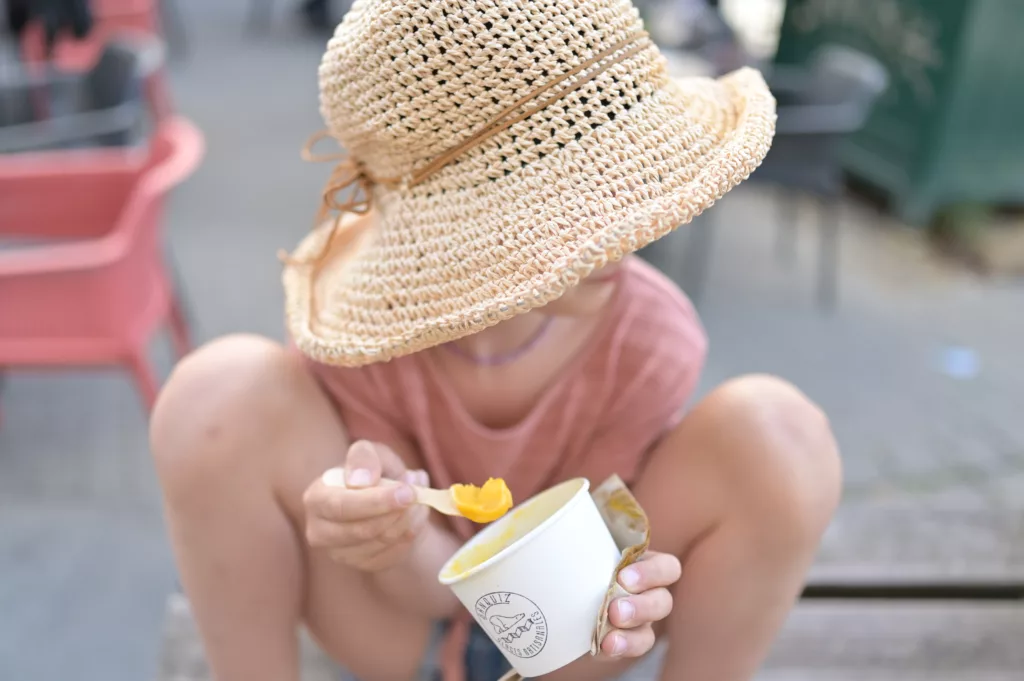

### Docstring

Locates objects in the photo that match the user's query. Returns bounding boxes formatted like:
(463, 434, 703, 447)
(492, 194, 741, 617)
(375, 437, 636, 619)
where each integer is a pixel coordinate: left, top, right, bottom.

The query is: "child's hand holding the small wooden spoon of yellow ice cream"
(303, 441, 429, 571)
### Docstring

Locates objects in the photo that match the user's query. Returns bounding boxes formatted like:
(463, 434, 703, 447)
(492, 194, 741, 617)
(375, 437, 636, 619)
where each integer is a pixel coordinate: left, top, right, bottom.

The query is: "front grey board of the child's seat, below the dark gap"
(153, 595, 1024, 681)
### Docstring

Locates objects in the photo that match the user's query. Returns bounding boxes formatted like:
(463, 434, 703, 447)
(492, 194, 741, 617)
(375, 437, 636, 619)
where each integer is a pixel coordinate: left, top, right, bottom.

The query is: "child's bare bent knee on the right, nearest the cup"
(694, 375, 842, 543)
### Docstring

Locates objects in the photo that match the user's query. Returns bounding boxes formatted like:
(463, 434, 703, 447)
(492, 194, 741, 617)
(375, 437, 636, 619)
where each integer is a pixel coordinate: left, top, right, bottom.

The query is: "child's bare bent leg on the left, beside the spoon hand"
(152, 337, 431, 681)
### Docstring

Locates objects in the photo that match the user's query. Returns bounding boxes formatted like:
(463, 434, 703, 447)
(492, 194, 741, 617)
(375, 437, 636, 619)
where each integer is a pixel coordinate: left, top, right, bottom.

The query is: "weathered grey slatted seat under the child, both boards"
(158, 506, 1024, 681)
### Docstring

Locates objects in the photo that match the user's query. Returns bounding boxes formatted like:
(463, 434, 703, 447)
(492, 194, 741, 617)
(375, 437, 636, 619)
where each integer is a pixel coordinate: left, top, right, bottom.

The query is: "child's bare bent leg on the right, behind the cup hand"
(556, 377, 841, 681)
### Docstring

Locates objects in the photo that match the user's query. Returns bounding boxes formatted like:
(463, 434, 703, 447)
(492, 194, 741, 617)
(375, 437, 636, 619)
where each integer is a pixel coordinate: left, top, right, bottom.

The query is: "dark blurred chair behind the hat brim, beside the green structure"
(681, 45, 889, 309)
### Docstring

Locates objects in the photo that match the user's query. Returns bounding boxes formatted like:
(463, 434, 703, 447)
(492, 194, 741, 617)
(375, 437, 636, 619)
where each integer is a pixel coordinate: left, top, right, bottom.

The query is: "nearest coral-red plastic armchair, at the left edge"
(0, 118, 205, 408)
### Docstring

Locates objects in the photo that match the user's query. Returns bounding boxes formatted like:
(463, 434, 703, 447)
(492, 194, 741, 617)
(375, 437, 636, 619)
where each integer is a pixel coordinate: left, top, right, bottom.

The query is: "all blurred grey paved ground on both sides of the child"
(0, 0, 1024, 681)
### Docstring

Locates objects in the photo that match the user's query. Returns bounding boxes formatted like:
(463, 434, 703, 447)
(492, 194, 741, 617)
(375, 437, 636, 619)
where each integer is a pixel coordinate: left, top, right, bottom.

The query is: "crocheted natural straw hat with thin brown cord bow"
(284, 0, 775, 366)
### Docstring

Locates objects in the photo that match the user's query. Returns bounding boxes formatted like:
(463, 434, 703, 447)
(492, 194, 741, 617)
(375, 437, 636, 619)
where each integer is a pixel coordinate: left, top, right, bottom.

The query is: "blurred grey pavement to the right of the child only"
(680, 187, 1024, 509)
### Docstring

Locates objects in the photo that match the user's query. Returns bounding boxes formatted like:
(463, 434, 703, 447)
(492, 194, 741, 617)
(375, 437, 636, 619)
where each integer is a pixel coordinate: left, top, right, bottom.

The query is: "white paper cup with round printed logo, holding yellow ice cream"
(438, 478, 621, 678)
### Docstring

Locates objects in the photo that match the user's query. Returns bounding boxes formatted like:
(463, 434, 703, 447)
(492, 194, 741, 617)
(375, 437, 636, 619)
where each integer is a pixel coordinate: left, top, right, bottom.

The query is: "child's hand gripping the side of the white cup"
(601, 551, 682, 657)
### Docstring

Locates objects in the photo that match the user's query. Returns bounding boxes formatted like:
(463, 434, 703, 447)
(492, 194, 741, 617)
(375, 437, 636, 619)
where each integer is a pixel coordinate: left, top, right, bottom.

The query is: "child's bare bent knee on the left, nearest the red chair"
(150, 335, 303, 495)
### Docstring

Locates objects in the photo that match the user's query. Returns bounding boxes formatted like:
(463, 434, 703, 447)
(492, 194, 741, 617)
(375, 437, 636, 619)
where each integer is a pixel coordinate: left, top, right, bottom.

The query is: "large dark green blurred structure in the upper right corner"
(775, 0, 1024, 225)
